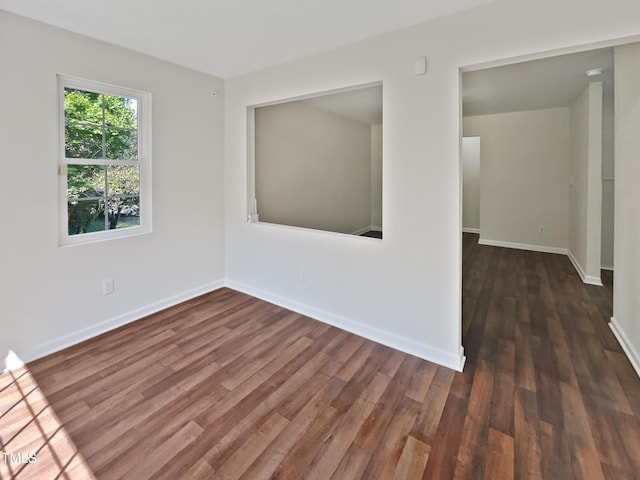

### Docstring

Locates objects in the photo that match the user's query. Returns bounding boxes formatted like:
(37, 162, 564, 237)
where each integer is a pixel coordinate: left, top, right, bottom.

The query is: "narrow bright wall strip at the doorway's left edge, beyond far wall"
(462, 137, 480, 233)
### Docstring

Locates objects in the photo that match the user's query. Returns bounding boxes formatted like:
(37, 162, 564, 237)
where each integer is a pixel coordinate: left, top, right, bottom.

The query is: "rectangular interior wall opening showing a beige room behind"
(247, 83, 382, 238)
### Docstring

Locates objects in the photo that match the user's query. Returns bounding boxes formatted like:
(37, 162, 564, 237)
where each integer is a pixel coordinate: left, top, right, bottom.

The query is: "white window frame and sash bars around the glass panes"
(58, 75, 152, 246)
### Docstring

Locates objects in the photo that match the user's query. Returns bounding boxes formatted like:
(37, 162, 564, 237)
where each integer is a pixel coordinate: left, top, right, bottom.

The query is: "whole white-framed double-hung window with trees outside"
(58, 76, 151, 245)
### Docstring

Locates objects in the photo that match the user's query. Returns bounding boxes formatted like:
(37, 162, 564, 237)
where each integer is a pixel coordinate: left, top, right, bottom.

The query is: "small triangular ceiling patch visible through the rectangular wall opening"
(302, 85, 382, 125)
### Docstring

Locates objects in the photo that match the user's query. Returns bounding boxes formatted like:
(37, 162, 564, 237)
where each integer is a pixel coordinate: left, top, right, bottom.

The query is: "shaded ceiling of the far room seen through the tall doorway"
(462, 48, 613, 116)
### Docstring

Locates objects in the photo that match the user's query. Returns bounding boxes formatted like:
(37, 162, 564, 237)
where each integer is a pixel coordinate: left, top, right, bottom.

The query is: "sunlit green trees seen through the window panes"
(64, 87, 140, 235)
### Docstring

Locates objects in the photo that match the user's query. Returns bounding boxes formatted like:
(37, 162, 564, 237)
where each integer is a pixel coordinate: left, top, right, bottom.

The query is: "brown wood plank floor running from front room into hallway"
(0, 234, 640, 480)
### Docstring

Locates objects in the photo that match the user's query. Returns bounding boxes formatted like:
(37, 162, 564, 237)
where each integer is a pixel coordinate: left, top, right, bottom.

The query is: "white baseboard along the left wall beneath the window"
(20, 280, 224, 363)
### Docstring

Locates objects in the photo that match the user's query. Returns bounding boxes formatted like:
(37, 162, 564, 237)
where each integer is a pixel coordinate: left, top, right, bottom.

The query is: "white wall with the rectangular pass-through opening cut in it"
(225, 0, 640, 368)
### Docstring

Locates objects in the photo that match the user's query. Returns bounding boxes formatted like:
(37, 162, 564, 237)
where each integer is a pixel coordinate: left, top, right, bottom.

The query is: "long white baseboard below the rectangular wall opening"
(225, 280, 465, 372)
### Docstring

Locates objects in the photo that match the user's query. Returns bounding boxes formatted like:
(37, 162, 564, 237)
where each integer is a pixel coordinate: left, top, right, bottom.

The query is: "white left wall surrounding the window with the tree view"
(0, 11, 224, 364)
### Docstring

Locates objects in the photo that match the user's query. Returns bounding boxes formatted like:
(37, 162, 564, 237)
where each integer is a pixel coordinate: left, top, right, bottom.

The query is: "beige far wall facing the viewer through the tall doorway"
(464, 108, 570, 251)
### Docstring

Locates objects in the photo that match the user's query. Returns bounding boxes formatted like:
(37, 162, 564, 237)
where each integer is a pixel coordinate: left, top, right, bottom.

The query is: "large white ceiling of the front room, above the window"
(0, 0, 493, 78)
